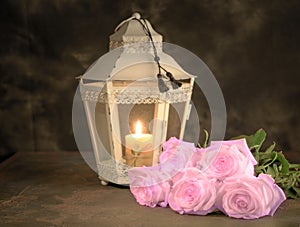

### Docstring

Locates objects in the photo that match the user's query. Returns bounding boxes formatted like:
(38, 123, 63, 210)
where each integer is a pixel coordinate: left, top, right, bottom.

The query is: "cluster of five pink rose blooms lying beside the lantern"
(129, 138, 286, 219)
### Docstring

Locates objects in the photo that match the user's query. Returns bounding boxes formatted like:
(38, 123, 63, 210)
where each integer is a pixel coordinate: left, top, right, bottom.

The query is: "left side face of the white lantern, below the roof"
(80, 79, 129, 185)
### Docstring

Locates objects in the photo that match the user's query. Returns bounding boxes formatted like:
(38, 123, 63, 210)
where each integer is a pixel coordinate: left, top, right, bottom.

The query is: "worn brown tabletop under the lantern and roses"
(0, 152, 300, 227)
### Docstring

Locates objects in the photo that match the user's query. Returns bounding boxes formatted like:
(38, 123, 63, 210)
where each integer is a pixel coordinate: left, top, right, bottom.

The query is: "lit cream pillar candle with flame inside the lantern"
(125, 121, 153, 166)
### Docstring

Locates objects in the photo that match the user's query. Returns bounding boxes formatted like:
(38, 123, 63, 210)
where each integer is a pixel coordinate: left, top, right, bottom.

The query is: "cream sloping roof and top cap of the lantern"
(83, 13, 194, 82)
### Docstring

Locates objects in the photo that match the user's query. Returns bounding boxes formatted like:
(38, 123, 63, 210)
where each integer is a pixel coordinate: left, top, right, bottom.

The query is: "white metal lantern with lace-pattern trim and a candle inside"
(80, 13, 194, 184)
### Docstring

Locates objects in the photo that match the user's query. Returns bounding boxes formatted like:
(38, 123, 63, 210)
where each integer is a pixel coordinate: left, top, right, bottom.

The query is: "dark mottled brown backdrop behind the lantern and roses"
(0, 0, 300, 159)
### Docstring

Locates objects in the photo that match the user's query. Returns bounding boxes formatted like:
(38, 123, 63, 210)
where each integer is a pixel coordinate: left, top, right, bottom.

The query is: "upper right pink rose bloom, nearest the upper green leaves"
(197, 139, 256, 181)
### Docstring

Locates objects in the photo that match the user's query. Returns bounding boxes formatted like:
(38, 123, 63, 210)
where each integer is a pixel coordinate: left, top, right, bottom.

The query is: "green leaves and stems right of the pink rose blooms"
(233, 129, 300, 199)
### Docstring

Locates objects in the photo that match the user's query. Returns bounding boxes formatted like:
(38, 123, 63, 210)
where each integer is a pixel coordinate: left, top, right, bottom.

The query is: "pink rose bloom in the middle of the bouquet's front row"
(168, 168, 216, 215)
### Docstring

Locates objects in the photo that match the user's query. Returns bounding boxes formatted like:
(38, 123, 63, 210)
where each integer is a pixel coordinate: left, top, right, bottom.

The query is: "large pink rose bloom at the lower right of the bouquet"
(216, 174, 286, 219)
